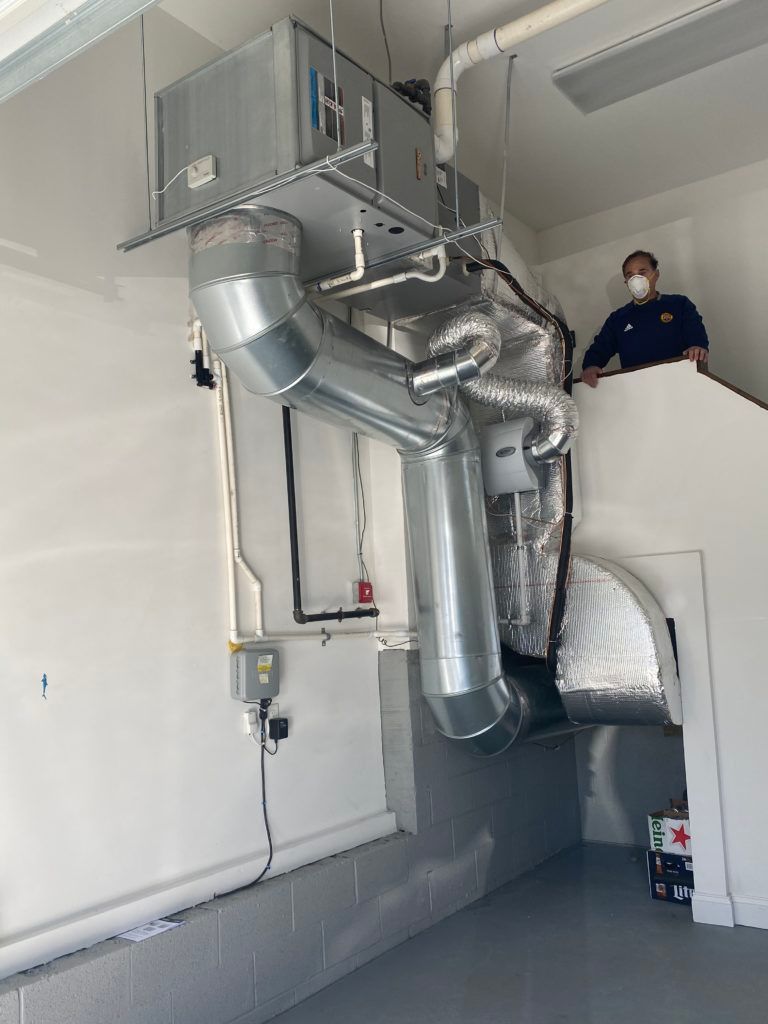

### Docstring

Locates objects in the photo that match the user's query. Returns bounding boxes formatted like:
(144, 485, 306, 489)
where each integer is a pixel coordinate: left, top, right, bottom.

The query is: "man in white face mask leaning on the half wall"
(582, 251, 710, 387)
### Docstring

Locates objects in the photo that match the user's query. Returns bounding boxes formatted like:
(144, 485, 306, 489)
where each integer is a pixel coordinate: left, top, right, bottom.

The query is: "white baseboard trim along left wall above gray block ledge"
(0, 811, 397, 978)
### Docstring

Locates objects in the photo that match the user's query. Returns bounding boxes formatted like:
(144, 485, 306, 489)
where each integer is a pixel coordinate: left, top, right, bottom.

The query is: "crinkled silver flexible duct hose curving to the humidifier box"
(427, 313, 579, 462)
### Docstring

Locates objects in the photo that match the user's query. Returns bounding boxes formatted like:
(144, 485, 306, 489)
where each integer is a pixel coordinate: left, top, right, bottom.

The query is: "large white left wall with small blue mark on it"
(0, 11, 399, 975)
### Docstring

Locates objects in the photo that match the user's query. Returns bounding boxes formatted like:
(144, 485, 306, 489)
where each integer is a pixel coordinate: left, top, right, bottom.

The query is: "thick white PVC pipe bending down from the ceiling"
(432, 0, 606, 164)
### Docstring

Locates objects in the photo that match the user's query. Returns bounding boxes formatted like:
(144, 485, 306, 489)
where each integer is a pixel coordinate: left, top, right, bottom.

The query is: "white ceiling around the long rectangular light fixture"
(156, 0, 768, 229)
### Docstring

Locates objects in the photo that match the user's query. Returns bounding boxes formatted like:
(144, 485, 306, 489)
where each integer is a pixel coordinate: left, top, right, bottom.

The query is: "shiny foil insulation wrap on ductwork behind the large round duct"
(399, 197, 681, 725)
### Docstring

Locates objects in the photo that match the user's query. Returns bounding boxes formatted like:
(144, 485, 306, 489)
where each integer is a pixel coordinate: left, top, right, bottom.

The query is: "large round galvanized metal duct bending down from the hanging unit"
(189, 207, 522, 754)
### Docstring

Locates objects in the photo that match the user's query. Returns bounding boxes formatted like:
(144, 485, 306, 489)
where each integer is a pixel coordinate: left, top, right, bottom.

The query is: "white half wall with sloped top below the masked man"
(574, 361, 768, 927)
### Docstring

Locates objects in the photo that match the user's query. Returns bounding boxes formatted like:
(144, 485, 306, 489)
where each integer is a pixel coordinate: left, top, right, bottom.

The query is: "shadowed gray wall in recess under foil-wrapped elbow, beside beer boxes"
(577, 726, 686, 846)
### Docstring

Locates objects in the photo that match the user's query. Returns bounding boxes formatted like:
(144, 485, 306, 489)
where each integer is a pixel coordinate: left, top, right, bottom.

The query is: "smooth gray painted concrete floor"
(274, 846, 768, 1024)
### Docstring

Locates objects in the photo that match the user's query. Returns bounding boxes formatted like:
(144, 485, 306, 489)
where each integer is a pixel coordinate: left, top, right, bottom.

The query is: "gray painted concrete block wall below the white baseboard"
(0, 651, 581, 1024)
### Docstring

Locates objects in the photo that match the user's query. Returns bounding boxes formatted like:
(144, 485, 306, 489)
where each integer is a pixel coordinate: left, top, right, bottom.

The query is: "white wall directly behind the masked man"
(538, 155, 768, 400)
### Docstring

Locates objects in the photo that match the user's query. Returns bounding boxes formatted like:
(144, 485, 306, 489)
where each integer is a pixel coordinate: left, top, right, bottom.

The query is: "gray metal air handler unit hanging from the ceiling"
(151, 17, 479, 319)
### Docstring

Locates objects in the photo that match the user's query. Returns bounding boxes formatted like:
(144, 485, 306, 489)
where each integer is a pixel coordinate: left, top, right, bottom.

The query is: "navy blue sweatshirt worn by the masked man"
(582, 295, 710, 369)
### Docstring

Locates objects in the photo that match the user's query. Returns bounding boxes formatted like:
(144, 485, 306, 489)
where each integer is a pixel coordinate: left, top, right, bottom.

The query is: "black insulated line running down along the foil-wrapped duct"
(467, 259, 573, 674)
